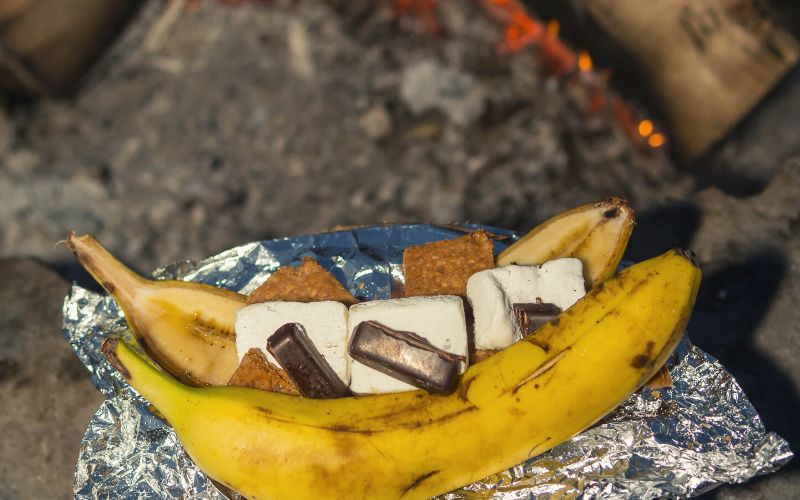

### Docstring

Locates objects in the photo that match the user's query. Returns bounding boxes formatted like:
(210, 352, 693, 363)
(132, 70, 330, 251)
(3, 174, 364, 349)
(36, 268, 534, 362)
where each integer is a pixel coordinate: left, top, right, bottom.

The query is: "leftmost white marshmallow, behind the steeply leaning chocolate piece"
(236, 301, 350, 384)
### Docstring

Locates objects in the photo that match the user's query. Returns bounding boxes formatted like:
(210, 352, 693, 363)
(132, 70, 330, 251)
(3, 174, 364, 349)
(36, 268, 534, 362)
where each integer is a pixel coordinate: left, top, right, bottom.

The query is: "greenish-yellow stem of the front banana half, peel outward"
(101, 338, 185, 420)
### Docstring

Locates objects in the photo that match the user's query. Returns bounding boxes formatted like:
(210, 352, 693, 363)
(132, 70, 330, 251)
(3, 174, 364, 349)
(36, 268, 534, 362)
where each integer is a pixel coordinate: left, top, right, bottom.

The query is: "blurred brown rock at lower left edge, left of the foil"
(0, 258, 103, 498)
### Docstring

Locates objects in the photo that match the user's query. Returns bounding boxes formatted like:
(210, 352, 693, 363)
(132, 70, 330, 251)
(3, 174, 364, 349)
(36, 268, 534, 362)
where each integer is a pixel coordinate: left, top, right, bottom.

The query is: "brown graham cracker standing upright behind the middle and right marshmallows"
(403, 230, 494, 297)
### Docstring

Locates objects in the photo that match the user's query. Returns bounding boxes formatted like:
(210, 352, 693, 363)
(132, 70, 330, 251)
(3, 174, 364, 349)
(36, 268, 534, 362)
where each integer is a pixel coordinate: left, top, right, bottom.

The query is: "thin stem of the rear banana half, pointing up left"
(66, 232, 147, 305)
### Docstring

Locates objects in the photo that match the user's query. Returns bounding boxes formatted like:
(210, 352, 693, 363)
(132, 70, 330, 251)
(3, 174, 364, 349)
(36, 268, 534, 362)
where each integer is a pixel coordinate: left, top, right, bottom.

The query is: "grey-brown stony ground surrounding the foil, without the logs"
(0, 1, 800, 498)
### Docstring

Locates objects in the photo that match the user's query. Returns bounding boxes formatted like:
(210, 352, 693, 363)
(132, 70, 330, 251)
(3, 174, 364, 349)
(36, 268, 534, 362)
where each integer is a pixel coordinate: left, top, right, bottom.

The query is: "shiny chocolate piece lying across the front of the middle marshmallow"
(348, 321, 466, 394)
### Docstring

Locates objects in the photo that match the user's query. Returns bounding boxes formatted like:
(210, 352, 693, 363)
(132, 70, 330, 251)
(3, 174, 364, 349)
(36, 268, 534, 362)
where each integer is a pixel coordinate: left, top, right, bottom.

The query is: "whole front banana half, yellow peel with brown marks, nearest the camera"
(103, 250, 700, 499)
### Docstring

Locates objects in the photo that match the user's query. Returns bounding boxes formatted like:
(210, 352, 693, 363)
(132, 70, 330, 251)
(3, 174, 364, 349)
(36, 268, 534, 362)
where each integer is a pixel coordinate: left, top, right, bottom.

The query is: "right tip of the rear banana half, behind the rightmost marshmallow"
(496, 198, 634, 287)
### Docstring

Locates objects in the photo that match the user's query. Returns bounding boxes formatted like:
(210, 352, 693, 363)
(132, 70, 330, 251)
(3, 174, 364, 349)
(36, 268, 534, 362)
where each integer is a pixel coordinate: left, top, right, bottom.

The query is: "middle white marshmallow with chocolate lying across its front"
(347, 295, 467, 394)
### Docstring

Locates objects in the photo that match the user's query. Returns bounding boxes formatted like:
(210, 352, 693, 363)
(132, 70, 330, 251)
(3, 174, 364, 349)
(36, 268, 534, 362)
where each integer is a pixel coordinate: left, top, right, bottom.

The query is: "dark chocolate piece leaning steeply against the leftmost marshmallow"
(267, 323, 350, 399)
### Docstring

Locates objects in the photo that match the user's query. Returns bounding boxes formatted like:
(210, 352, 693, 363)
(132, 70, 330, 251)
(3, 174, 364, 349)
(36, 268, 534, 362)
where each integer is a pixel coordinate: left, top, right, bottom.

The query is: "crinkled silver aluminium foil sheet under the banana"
(64, 225, 792, 499)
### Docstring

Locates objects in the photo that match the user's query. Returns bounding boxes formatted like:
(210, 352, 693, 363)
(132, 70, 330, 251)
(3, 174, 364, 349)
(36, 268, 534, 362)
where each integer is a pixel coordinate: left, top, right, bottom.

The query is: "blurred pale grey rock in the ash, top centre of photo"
(400, 60, 486, 127)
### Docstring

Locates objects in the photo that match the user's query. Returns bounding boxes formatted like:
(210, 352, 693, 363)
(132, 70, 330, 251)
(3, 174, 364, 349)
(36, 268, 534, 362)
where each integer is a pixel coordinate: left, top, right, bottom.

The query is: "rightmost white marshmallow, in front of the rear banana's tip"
(467, 259, 586, 349)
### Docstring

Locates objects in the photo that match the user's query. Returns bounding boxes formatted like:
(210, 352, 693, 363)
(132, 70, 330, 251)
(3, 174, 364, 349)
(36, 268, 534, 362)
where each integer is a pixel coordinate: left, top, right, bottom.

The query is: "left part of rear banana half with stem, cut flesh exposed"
(66, 233, 246, 386)
